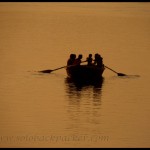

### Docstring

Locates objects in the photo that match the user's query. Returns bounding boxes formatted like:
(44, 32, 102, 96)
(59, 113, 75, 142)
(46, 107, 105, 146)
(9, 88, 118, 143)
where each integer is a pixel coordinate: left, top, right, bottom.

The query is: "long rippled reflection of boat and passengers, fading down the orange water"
(65, 78, 104, 134)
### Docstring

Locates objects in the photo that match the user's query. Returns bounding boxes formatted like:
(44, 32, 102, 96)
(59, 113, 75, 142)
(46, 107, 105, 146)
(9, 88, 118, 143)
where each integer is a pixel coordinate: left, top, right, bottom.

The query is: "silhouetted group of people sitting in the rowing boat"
(67, 53, 103, 67)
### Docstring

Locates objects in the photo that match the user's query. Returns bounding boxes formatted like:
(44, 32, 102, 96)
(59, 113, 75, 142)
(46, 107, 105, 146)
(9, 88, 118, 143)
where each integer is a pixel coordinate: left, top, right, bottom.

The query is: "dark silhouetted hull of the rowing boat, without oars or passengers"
(66, 65, 105, 81)
